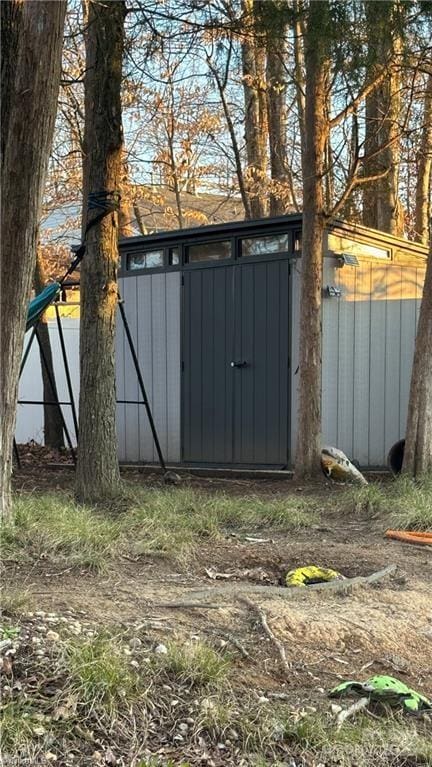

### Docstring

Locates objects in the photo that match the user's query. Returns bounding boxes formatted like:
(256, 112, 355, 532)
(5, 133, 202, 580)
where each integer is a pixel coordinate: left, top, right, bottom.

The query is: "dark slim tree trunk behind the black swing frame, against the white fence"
(34, 248, 64, 450)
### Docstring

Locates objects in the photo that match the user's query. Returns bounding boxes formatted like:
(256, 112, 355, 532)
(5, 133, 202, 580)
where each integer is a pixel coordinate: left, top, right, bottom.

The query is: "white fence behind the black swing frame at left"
(15, 317, 79, 445)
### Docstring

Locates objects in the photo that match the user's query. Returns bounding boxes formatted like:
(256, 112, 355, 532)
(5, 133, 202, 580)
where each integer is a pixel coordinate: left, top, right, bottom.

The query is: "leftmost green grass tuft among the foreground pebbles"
(64, 634, 140, 716)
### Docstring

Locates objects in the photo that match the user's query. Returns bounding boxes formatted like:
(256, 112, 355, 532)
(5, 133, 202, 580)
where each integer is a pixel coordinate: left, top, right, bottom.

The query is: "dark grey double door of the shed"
(182, 260, 289, 467)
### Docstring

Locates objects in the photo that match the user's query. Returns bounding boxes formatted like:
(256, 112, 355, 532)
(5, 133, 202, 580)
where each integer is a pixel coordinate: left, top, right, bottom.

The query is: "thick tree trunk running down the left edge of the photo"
(0, 0, 66, 518)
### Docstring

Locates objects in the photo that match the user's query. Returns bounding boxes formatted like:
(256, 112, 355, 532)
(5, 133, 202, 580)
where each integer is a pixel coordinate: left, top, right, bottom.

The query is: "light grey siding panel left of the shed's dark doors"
(116, 272, 181, 463)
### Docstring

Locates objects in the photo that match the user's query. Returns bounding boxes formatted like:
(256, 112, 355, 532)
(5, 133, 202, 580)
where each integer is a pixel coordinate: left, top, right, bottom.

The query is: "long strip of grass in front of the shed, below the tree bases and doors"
(0, 487, 316, 570)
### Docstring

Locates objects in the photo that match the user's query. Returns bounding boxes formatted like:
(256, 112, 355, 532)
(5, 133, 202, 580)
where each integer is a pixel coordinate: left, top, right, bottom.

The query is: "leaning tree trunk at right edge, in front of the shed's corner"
(403, 238, 432, 477)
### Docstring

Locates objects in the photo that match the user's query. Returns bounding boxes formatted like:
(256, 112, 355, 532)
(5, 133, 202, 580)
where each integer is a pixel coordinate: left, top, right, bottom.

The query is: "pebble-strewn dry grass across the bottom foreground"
(1, 619, 432, 767)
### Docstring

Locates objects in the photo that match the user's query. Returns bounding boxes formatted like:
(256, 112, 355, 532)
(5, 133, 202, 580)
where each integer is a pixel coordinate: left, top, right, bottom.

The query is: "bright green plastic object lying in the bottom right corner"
(329, 675, 432, 714)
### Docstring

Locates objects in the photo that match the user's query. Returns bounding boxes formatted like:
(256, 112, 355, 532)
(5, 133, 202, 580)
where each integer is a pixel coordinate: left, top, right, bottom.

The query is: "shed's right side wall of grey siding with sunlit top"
(322, 261, 424, 466)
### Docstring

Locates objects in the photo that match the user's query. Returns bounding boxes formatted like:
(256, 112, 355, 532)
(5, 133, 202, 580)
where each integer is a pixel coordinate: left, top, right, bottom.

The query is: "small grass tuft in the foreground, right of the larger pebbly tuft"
(153, 641, 231, 688)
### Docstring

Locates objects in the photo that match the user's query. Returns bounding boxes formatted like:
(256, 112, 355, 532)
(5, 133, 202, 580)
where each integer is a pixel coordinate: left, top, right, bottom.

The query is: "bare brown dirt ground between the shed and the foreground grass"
(6, 469, 432, 707)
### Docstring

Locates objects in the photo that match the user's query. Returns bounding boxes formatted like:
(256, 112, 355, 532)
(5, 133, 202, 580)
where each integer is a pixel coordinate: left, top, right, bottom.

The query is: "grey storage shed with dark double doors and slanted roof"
(117, 215, 427, 469)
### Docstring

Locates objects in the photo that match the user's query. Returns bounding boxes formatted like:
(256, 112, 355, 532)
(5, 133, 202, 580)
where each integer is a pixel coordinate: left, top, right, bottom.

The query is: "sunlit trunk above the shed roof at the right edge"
(415, 74, 432, 245)
